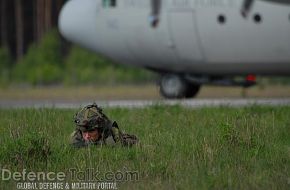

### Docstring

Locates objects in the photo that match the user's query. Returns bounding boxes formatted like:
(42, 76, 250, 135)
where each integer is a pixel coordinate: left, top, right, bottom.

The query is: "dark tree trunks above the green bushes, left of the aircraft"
(0, 0, 66, 60)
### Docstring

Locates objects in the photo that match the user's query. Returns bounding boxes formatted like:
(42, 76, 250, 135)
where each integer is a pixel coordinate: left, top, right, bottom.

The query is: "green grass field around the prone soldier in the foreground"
(0, 105, 290, 190)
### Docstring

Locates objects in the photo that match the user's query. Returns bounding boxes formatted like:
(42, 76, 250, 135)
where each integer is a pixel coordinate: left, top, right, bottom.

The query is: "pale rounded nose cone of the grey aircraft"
(58, 0, 97, 49)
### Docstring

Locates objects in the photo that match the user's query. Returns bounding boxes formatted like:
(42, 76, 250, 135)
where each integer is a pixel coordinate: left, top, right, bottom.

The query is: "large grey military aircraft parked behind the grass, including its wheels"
(59, 0, 290, 98)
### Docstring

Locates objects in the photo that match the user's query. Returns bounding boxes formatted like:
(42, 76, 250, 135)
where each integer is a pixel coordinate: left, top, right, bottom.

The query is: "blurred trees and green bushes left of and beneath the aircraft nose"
(0, 0, 153, 87)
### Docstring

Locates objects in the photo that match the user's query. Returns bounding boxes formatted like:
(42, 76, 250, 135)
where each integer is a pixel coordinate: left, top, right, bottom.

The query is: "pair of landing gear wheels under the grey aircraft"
(160, 74, 200, 98)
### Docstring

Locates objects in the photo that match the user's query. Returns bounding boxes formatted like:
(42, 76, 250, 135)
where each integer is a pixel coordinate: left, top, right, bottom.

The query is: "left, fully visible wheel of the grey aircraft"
(160, 74, 188, 98)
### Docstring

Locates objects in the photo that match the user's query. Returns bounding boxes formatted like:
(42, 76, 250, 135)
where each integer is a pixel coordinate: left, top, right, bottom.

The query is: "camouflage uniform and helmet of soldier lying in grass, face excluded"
(71, 104, 138, 148)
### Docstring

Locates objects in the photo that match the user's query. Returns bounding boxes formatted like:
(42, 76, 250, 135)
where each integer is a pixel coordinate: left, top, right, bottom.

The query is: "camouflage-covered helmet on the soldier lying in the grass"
(74, 103, 108, 131)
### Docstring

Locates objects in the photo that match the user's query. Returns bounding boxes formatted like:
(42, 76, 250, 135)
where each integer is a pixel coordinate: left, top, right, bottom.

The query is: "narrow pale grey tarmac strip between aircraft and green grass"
(0, 98, 290, 109)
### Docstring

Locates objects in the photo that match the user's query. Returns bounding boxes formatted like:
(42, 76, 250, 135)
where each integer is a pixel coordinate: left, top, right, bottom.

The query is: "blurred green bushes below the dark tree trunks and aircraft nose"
(0, 30, 156, 86)
